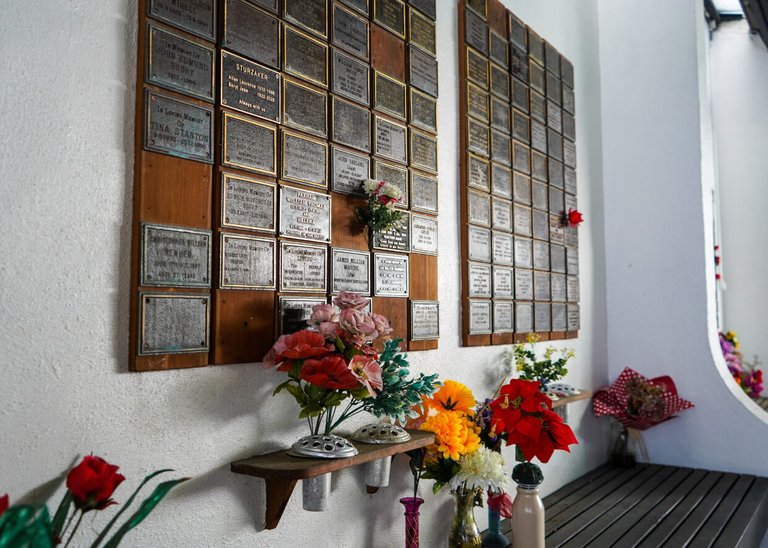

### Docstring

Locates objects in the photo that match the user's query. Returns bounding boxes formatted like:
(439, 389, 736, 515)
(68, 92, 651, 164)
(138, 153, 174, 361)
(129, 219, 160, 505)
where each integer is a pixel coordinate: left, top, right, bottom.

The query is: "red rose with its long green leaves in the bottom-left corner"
(0, 455, 189, 548)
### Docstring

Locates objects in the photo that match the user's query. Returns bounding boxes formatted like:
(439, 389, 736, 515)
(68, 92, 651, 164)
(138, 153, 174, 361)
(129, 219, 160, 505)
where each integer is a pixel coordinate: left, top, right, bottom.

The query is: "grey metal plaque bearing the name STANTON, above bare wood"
(144, 90, 213, 164)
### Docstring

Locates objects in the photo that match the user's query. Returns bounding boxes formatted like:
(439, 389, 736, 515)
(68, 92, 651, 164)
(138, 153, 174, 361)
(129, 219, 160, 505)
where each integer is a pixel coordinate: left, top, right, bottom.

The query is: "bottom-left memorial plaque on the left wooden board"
(138, 291, 211, 356)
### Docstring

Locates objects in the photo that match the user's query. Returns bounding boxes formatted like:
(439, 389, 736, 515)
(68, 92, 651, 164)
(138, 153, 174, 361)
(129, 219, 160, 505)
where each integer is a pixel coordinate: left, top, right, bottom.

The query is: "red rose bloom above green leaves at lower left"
(67, 455, 125, 512)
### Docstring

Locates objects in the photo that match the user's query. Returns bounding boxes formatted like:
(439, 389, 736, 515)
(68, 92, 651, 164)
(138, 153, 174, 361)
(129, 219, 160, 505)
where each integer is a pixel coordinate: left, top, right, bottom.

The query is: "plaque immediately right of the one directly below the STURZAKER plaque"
(282, 129, 328, 188)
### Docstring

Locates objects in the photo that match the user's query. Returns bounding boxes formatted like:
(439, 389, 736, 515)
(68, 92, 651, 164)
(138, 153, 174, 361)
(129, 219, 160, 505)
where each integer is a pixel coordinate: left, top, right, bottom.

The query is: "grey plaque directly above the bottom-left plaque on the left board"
(140, 223, 211, 287)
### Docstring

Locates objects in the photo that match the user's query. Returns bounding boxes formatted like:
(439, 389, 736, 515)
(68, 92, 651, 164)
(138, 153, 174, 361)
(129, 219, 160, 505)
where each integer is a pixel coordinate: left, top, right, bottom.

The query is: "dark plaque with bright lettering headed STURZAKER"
(221, 51, 280, 122)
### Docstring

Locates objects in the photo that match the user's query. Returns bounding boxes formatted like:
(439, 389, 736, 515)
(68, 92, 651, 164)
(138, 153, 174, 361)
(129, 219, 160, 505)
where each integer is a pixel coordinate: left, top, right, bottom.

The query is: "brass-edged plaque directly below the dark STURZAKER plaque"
(222, 112, 277, 175)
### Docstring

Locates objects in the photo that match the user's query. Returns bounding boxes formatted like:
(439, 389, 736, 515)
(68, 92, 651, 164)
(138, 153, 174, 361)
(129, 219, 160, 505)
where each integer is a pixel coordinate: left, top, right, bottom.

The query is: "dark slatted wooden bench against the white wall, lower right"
(502, 464, 768, 548)
